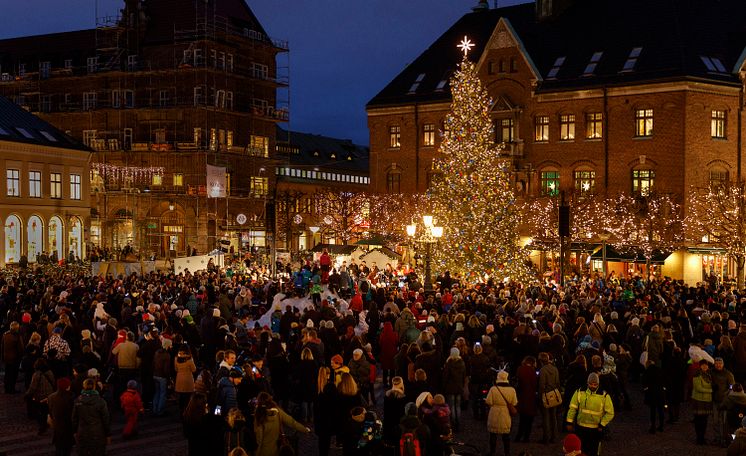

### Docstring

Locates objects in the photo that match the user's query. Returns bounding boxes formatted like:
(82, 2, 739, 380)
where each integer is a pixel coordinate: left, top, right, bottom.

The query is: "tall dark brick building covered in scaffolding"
(0, 0, 288, 256)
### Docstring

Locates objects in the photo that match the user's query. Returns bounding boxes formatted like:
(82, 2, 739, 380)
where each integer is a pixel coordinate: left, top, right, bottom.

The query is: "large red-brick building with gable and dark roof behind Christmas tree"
(367, 0, 746, 281)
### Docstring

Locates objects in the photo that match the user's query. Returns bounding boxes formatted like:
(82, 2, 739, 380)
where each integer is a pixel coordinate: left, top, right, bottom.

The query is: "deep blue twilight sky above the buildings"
(0, 0, 526, 144)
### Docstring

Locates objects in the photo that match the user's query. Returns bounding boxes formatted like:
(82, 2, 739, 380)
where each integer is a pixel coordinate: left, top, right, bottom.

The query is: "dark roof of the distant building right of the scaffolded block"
(277, 127, 369, 174)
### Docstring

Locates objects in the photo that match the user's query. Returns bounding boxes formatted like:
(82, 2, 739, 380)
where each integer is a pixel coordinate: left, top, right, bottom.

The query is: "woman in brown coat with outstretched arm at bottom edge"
(254, 392, 311, 456)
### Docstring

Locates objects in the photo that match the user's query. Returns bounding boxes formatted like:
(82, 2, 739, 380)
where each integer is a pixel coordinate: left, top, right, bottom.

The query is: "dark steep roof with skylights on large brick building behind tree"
(368, 0, 746, 107)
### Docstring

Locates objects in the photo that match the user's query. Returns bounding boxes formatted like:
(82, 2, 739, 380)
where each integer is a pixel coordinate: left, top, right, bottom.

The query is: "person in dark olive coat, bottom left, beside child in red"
(72, 378, 111, 456)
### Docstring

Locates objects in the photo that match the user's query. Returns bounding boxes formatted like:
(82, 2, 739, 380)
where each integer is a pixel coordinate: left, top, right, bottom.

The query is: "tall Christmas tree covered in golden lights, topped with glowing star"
(430, 37, 533, 281)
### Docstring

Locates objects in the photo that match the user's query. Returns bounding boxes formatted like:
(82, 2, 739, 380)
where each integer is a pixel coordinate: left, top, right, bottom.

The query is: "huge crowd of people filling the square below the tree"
(0, 253, 746, 456)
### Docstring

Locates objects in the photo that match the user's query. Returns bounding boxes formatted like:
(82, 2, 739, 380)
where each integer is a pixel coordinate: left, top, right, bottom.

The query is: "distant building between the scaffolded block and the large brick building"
(274, 127, 370, 251)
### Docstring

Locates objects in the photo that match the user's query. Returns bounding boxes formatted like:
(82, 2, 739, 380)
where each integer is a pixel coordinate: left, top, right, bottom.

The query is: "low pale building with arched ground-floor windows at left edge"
(0, 97, 91, 265)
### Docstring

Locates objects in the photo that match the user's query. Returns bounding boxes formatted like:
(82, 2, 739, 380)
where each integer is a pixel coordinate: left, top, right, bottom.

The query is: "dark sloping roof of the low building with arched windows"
(0, 96, 90, 151)
